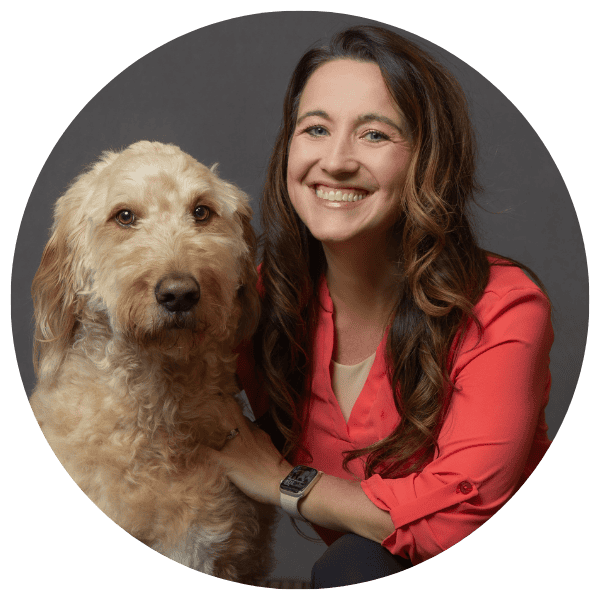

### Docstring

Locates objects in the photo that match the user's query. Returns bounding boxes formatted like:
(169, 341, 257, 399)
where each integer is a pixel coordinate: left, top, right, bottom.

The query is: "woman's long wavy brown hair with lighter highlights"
(254, 26, 548, 477)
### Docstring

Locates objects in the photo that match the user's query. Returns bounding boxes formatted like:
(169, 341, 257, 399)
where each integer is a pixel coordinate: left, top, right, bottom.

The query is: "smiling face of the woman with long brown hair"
(287, 59, 410, 243)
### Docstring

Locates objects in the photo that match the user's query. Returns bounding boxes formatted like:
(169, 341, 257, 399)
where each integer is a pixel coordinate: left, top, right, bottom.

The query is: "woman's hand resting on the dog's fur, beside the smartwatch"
(210, 401, 292, 506)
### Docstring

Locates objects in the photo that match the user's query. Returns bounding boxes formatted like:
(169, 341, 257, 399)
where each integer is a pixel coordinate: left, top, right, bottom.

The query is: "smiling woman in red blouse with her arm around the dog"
(207, 27, 553, 587)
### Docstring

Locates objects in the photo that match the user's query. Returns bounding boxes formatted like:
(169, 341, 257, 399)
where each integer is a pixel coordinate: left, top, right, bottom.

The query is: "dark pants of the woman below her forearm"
(310, 533, 412, 589)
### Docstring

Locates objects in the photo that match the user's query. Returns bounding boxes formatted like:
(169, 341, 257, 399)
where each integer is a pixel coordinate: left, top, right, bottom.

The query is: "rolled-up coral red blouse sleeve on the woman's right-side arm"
(362, 285, 553, 564)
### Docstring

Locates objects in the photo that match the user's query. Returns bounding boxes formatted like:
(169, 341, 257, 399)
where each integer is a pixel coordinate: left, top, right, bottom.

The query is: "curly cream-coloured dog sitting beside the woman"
(31, 141, 275, 585)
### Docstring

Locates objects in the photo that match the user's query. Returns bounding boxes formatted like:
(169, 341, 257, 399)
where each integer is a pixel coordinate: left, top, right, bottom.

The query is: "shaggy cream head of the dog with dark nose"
(32, 142, 258, 377)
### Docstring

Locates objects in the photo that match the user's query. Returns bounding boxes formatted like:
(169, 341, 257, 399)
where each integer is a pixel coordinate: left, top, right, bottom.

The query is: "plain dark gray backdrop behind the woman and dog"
(11, 11, 589, 577)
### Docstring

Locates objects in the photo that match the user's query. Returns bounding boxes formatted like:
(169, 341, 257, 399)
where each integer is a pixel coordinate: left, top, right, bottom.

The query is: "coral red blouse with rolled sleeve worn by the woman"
(238, 264, 553, 564)
